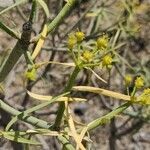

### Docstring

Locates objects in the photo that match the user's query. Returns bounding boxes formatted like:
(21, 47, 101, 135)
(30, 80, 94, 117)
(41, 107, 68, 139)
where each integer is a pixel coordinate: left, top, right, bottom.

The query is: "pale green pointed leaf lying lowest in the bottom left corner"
(2, 132, 40, 145)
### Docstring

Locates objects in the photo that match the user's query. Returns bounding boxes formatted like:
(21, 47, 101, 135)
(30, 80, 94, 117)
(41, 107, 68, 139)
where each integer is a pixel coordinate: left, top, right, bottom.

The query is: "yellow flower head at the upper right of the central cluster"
(97, 35, 108, 50)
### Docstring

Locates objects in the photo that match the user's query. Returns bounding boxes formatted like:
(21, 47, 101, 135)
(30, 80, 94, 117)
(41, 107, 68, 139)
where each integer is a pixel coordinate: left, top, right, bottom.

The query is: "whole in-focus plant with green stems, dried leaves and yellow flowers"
(0, 0, 150, 150)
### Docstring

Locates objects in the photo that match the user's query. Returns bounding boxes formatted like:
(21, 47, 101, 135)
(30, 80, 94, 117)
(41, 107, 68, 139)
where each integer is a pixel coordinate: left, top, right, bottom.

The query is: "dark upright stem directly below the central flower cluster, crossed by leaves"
(53, 66, 80, 130)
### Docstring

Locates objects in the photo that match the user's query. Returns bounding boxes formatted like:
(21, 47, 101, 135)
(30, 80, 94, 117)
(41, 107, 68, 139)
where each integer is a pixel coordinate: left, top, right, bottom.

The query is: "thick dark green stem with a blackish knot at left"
(0, 0, 35, 82)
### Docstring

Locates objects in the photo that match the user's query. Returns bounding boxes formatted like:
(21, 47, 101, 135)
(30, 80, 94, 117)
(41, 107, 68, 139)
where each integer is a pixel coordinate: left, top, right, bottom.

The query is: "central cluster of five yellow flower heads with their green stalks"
(67, 31, 113, 69)
